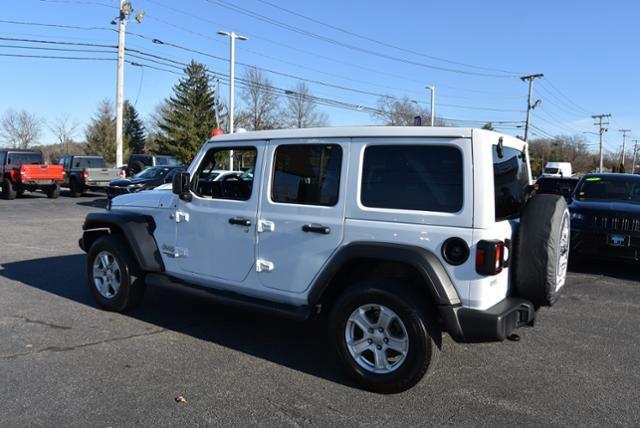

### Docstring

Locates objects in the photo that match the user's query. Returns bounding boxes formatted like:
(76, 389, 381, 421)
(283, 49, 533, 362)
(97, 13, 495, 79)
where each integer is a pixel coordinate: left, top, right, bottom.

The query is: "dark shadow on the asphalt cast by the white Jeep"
(0, 254, 354, 386)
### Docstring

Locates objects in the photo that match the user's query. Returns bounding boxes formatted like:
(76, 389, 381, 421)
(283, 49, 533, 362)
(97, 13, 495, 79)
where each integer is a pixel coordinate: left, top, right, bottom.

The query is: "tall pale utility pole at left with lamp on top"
(111, 0, 144, 166)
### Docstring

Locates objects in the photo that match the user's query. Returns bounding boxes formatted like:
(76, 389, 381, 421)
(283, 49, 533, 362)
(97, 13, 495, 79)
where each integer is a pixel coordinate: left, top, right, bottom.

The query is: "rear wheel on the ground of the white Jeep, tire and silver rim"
(329, 279, 441, 394)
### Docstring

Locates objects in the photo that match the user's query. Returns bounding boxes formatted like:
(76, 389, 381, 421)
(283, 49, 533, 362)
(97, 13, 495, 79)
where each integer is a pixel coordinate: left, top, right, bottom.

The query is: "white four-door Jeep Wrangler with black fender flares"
(80, 127, 569, 393)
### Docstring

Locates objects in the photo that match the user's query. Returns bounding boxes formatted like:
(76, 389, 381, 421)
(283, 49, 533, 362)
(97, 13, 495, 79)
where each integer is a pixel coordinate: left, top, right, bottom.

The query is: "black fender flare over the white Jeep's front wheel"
(80, 211, 164, 272)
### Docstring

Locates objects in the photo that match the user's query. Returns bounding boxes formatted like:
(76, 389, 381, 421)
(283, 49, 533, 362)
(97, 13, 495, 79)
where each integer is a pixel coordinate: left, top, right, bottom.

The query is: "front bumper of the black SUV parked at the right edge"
(571, 229, 640, 261)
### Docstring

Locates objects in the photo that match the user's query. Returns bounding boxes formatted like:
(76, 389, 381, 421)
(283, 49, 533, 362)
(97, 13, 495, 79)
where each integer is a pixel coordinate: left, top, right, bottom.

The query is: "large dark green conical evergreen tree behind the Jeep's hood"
(157, 61, 217, 163)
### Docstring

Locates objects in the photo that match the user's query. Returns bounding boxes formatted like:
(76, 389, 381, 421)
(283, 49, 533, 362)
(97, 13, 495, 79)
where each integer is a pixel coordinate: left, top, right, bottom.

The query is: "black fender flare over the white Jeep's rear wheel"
(308, 242, 460, 306)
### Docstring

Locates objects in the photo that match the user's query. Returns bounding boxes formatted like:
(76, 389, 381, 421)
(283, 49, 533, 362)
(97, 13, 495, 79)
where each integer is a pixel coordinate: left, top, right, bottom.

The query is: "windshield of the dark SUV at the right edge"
(575, 174, 640, 202)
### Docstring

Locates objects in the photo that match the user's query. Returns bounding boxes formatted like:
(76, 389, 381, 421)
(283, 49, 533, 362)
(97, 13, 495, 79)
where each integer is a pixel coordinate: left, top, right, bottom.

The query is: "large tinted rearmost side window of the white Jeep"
(361, 144, 463, 213)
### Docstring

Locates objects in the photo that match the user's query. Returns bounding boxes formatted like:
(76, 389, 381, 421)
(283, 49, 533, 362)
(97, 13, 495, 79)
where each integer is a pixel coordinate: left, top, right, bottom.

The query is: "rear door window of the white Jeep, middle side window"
(271, 144, 342, 206)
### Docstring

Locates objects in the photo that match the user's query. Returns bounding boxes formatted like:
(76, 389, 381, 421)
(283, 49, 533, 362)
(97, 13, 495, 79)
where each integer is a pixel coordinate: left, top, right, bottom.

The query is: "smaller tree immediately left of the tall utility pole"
(86, 100, 116, 163)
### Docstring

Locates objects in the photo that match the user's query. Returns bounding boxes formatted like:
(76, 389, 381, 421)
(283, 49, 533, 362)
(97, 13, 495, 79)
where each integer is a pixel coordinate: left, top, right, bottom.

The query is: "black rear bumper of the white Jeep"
(439, 297, 535, 343)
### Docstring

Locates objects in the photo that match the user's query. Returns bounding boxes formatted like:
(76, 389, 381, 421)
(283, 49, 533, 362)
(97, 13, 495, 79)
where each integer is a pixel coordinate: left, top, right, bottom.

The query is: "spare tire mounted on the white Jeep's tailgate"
(514, 195, 571, 308)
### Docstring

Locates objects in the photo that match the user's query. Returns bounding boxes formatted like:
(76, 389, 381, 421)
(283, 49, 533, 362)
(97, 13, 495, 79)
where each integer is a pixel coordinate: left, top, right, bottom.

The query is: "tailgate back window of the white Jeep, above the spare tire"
(493, 146, 529, 221)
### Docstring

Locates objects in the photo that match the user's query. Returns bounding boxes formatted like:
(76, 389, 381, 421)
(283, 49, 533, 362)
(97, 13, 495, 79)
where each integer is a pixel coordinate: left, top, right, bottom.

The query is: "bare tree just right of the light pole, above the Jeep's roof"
(238, 68, 281, 131)
